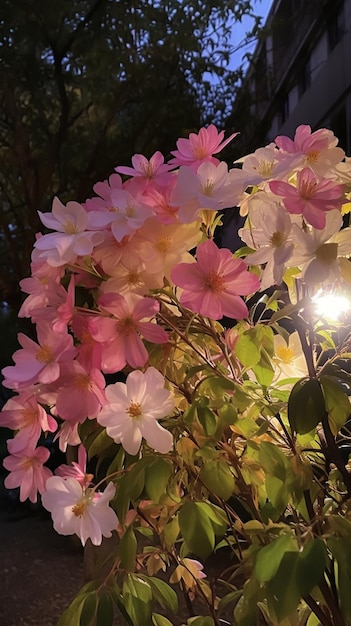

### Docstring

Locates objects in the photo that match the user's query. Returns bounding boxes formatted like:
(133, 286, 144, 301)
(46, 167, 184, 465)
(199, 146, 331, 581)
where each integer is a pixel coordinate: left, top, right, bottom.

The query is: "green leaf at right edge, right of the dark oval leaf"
(320, 376, 351, 435)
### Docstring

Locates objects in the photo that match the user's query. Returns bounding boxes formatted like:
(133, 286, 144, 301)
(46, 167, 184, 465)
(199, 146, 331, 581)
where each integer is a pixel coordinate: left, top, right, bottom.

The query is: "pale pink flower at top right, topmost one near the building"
(275, 124, 345, 176)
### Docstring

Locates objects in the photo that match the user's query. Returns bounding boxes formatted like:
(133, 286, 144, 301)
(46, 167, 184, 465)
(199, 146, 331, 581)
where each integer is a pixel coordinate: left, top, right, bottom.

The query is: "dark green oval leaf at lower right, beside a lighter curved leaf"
(296, 537, 328, 596)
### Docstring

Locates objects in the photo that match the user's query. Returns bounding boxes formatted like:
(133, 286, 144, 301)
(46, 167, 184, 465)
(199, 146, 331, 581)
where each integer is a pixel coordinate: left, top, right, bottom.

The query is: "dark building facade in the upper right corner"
(229, 0, 351, 154)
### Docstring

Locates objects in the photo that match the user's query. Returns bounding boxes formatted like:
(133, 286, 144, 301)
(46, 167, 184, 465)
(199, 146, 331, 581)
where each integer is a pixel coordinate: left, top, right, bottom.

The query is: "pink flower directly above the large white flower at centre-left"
(89, 294, 168, 373)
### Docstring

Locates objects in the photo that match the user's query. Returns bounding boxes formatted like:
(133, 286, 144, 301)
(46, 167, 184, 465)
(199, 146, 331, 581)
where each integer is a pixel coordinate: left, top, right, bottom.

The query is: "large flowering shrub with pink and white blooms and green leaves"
(0, 125, 351, 626)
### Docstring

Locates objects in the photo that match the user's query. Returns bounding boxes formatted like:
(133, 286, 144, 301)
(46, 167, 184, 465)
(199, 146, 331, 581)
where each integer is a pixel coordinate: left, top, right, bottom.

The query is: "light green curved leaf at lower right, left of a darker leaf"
(255, 533, 297, 583)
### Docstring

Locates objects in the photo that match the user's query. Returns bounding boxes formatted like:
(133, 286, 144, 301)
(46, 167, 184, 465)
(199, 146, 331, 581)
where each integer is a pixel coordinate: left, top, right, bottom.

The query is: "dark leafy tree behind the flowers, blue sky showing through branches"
(0, 0, 259, 308)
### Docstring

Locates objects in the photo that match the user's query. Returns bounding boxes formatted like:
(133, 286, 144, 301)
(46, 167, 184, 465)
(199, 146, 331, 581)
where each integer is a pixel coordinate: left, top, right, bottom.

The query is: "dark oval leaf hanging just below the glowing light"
(288, 378, 325, 435)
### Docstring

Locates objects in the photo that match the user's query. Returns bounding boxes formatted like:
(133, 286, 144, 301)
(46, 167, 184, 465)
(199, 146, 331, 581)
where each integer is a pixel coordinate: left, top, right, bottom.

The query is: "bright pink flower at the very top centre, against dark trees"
(169, 124, 238, 171)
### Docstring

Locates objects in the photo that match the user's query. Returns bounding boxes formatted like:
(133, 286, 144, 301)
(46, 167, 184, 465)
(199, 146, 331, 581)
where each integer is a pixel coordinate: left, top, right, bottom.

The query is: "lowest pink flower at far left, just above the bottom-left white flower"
(3, 440, 52, 503)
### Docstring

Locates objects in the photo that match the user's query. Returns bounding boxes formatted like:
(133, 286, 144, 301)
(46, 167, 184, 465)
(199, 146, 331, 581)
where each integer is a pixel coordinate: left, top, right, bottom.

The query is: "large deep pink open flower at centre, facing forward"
(171, 239, 260, 320)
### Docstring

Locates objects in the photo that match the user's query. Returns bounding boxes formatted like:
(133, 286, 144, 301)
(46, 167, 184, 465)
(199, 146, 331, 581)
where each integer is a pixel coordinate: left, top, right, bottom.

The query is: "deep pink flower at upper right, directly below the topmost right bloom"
(269, 167, 344, 229)
